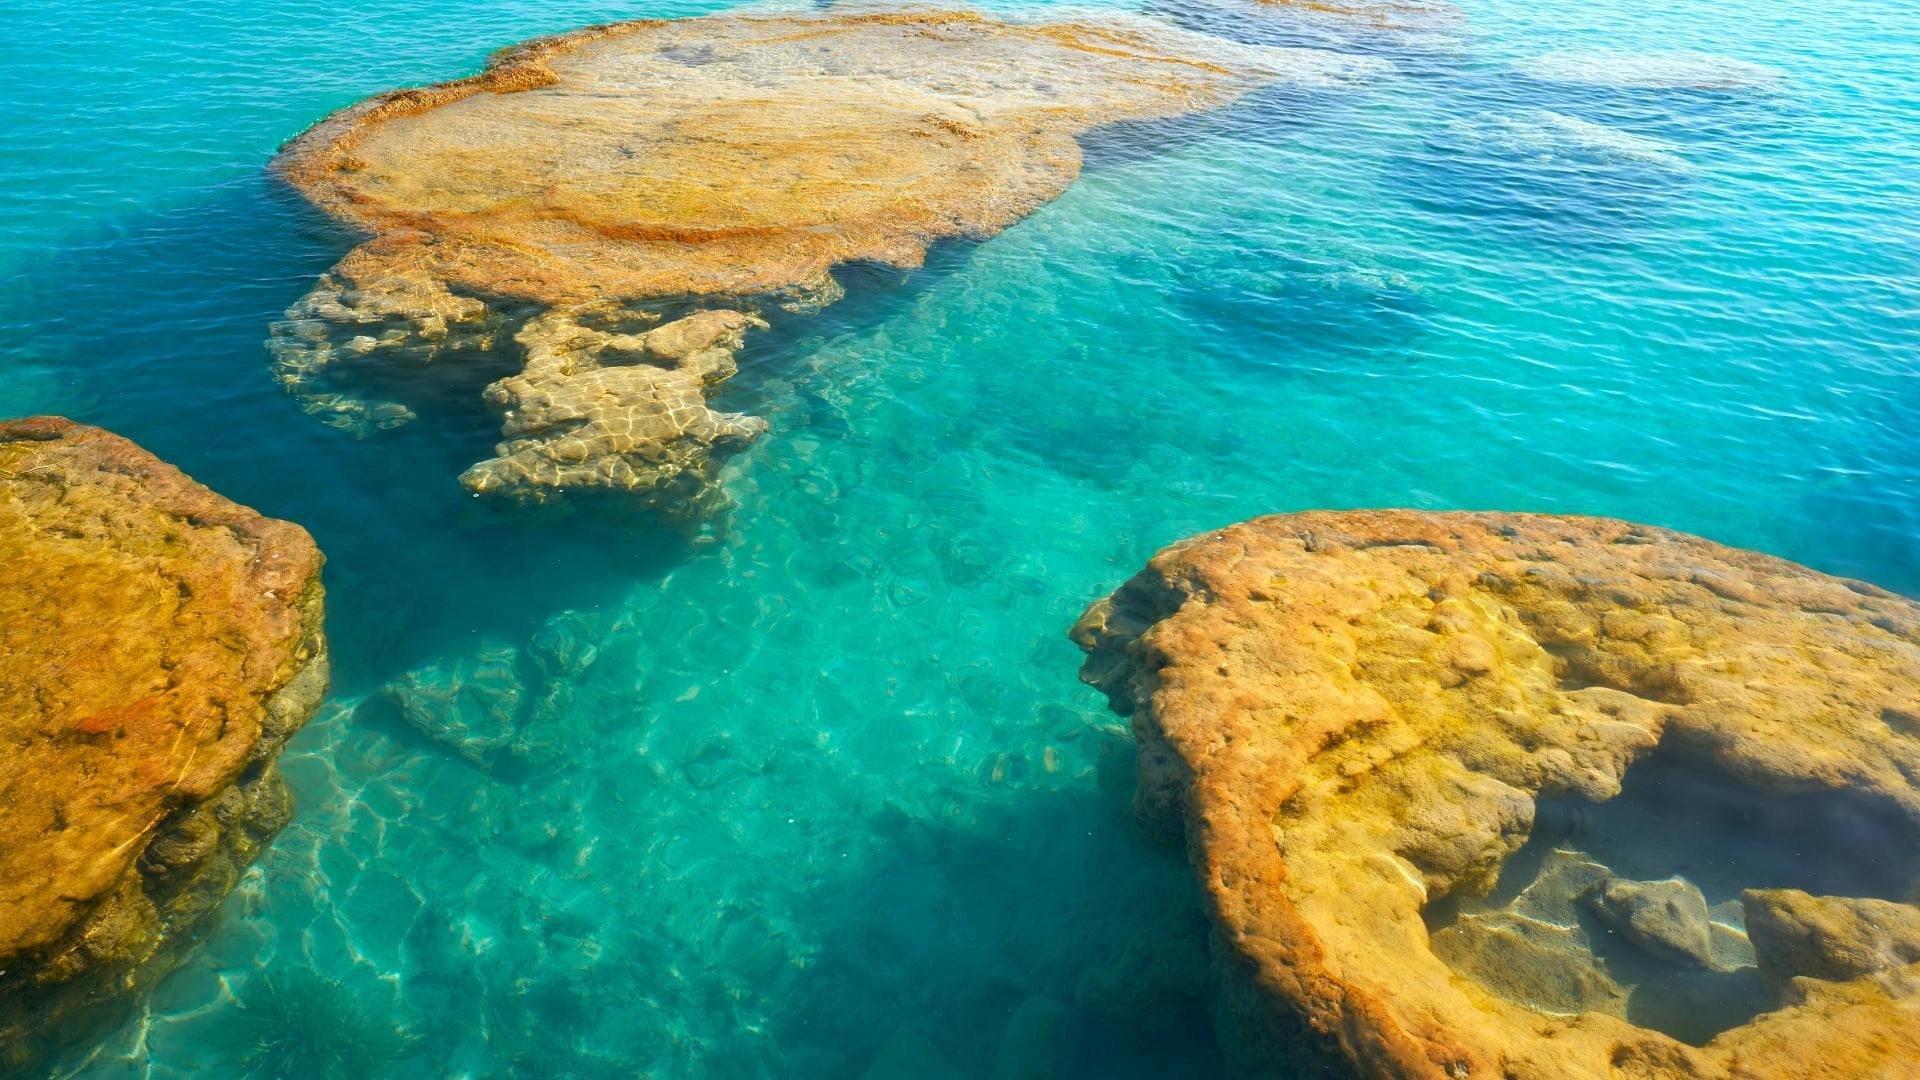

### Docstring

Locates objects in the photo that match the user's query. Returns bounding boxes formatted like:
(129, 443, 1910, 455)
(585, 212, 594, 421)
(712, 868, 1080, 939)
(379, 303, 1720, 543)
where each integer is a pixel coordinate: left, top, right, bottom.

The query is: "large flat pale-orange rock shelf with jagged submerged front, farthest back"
(271, 12, 1365, 509)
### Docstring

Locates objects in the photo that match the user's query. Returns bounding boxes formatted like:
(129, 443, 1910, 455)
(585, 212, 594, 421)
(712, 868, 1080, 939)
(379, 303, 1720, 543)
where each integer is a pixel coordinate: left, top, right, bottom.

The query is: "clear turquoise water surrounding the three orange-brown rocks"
(0, 0, 1920, 1076)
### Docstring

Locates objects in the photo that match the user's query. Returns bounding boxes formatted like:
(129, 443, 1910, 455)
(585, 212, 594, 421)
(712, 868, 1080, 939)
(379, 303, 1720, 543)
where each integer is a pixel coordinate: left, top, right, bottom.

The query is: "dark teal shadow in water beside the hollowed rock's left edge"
(774, 764, 1352, 1080)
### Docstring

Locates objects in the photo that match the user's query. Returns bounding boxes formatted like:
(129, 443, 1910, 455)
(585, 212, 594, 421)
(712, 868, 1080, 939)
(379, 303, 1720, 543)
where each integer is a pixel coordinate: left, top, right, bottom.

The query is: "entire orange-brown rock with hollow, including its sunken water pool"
(1073, 511, 1920, 1080)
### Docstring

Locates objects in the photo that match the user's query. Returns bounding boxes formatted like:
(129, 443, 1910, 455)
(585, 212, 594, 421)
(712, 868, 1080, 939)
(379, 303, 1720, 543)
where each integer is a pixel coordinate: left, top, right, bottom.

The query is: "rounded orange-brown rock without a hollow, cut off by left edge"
(0, 417, 326, 1074)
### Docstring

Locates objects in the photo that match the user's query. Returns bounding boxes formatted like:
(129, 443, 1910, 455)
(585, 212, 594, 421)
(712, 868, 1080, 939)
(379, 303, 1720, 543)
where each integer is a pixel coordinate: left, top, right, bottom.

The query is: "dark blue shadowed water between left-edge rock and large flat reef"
(0, 173, 691, 692)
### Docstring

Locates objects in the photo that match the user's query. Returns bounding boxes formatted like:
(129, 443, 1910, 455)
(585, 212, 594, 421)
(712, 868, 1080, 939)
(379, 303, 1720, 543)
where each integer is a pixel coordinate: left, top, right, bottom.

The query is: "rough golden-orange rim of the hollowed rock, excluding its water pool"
(1073, 511, 1920, 1080)
